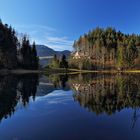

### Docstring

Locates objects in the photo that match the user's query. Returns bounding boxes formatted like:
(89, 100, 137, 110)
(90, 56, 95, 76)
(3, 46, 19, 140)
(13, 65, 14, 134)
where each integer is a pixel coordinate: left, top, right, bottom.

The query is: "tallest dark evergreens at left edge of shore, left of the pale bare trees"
(0, 21, 18, 69)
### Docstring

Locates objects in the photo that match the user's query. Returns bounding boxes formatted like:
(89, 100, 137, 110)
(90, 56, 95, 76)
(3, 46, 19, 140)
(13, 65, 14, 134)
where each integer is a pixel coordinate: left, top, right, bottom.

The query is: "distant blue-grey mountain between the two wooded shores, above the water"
(36, 45, 71, 67)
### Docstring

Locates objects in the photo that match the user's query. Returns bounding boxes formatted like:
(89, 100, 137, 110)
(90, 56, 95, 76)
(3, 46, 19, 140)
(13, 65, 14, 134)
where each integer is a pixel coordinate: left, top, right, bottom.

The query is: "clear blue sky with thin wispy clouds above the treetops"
(0, 0, 140, 50)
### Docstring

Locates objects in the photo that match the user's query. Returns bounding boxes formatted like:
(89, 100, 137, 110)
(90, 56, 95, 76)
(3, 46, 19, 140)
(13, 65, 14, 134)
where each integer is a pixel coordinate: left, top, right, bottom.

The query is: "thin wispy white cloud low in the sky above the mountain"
(16, 24, 73, 50)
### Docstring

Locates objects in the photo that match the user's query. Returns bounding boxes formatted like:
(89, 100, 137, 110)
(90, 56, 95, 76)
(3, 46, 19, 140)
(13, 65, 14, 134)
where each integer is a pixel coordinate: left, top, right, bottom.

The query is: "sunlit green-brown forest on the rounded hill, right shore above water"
(70, 28, 140, 69)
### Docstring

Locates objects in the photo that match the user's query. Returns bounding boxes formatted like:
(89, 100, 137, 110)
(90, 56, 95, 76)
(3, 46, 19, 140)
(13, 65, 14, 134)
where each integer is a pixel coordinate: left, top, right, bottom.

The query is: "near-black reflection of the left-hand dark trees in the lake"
(0, 75, 38, 121)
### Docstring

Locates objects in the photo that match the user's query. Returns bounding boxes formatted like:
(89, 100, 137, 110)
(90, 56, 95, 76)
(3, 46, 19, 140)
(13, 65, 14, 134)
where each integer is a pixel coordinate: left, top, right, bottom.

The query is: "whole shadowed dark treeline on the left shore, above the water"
(0, 21, 38, 69)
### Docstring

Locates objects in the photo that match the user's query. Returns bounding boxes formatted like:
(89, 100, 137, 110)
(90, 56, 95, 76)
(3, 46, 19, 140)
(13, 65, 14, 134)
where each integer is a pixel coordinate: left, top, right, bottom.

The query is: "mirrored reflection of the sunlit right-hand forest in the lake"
(69, 75, 140, 115)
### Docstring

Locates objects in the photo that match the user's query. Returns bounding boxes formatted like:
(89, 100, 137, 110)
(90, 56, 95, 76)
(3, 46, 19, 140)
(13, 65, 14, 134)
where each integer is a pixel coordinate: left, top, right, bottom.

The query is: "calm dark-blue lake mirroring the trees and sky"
(0, 74, 140, 140)
